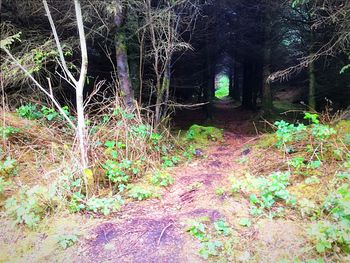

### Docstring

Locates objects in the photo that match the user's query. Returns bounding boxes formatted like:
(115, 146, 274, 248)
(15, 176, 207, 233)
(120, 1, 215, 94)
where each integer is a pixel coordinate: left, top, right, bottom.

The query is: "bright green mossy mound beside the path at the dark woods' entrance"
(186, 124, 223, 146)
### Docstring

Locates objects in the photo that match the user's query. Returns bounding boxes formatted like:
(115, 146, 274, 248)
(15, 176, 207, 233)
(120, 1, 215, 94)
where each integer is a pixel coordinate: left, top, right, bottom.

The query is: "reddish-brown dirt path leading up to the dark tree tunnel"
(77, 133, 262, 262)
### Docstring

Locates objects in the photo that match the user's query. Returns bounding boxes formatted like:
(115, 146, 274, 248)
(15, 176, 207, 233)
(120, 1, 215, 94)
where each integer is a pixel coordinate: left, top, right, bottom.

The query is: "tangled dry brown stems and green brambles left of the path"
(0, 98, 205, 228)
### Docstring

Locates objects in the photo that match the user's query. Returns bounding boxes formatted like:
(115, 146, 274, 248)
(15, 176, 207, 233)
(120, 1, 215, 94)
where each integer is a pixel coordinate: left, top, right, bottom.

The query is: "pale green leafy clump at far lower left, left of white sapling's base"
(5, 186, 57, 228)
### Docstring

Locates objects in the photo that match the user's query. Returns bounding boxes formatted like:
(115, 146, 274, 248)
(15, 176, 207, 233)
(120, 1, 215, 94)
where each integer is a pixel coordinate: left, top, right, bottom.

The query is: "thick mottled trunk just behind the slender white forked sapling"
(114, 5, 134, 109)
